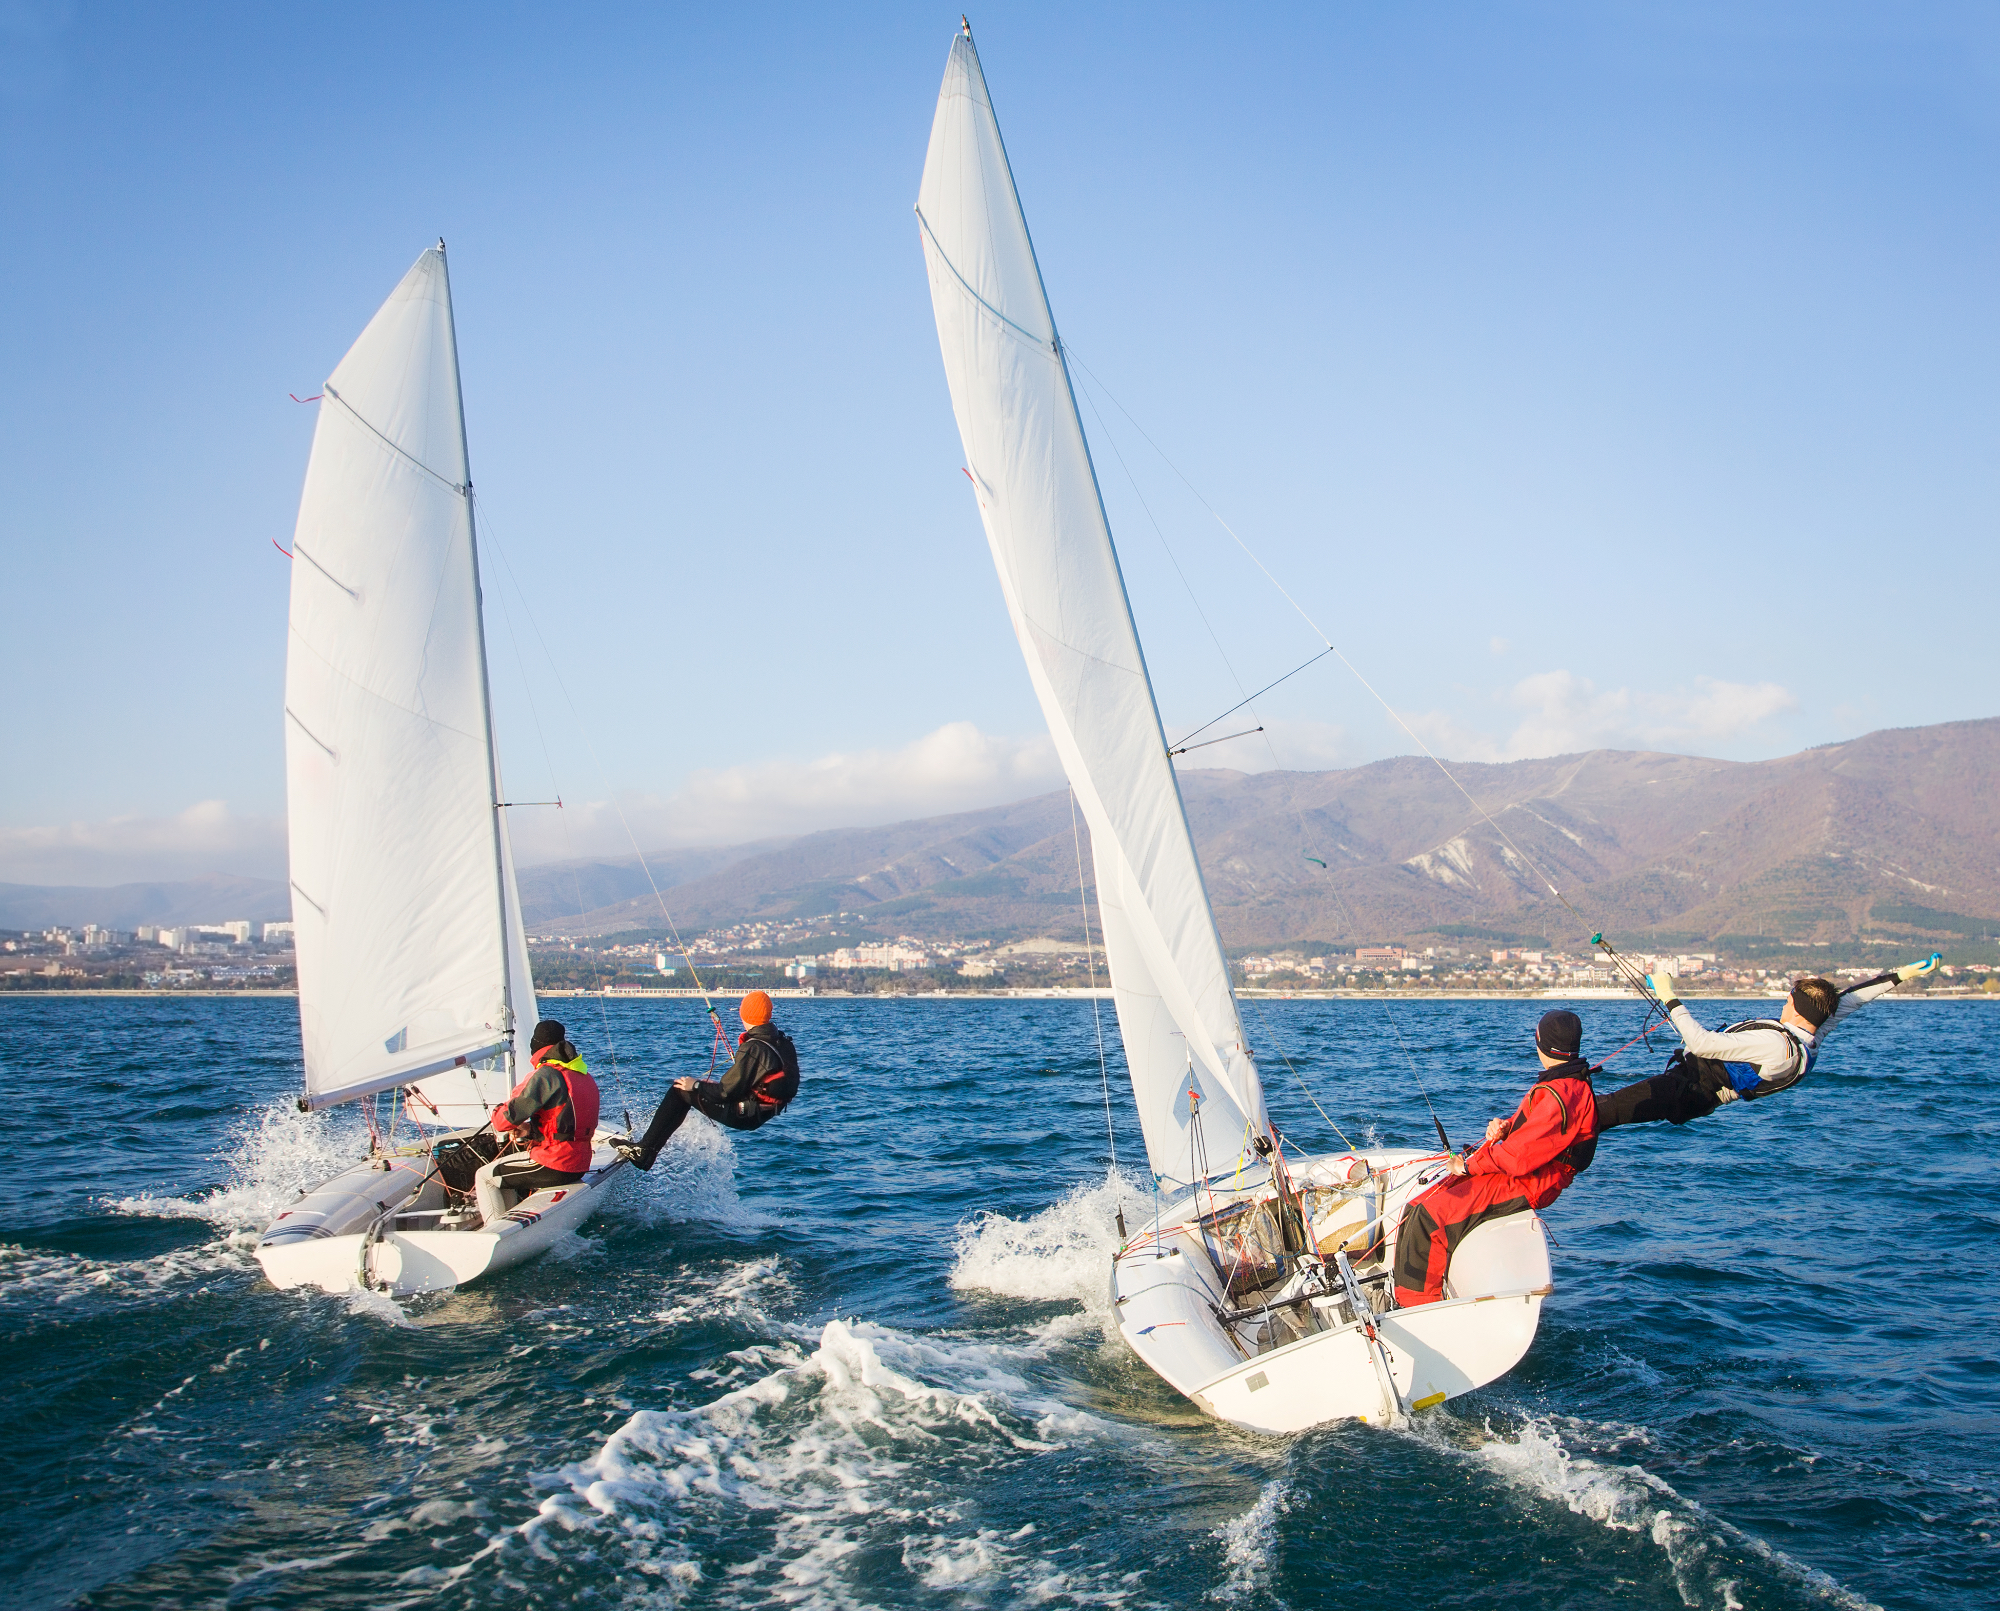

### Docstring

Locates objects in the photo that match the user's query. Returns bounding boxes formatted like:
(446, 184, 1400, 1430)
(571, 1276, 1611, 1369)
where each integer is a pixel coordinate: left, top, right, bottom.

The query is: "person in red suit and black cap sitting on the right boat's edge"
(1396, 1009, 1598, 1309)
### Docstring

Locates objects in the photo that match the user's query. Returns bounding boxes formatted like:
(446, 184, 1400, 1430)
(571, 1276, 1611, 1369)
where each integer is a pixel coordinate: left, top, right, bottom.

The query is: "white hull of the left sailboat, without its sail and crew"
(256, 1129, 626, 1297)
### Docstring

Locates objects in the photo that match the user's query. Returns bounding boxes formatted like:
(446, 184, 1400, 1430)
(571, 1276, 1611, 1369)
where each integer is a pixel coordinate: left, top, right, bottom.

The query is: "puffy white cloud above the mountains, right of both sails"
(1410, 672, 1798, 762)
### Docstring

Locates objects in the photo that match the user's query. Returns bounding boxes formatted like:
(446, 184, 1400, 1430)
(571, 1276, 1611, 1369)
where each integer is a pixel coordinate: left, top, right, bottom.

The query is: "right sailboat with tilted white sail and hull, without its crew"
(916, 26, 1552, 1433)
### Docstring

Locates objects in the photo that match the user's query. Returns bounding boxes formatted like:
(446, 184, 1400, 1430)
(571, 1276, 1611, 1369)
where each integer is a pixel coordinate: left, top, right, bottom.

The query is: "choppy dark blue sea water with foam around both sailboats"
(0, 997, 2000, 1607)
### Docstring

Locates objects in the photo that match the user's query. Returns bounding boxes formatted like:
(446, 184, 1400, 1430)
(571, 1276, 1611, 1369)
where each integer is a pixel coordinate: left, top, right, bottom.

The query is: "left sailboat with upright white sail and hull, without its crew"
(256, 240, 624, 1293)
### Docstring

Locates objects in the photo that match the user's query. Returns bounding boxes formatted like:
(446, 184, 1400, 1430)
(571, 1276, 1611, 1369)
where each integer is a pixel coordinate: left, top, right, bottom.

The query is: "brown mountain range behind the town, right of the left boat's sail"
(522, 718, 2000, 945)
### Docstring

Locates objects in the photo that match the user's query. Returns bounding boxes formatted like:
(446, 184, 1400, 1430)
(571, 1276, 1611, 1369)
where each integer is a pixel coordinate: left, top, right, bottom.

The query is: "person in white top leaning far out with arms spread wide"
(1598, 955, 1944, 1135)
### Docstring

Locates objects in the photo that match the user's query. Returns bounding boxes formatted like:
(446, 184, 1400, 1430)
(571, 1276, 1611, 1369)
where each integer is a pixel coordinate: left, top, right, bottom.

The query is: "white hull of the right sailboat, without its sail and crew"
(1112, 1151, 1552, 1433)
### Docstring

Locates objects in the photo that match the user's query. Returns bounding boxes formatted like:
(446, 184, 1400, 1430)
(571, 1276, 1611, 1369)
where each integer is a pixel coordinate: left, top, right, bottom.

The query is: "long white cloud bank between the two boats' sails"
(510, 722, 1062, 865)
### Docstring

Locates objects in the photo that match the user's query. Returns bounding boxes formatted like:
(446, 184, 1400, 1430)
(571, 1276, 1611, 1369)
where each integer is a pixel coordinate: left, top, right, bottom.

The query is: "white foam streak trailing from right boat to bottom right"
(1456, 1417, 1882, 1611)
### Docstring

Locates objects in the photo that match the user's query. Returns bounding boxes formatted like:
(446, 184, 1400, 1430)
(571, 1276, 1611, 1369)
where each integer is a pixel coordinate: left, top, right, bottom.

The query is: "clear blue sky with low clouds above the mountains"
(0, 0, 2000, 883)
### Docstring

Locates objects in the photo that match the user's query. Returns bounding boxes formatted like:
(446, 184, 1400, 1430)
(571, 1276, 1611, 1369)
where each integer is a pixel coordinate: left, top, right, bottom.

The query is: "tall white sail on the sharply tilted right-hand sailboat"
(916, 34, 1268, 1181)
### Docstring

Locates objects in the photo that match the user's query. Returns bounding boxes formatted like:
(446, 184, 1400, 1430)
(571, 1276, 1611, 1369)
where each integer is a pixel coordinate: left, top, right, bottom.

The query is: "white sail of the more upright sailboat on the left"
(284, 246, 534, 1117)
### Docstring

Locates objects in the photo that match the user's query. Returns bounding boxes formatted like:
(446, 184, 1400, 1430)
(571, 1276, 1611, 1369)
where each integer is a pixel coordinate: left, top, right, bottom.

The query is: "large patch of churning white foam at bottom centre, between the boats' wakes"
(522, 1321, 1126, 1605)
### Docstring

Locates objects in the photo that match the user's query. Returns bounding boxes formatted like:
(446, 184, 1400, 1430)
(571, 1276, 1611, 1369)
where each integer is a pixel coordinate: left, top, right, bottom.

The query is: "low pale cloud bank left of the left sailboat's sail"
(0, 800, 284, 885)
